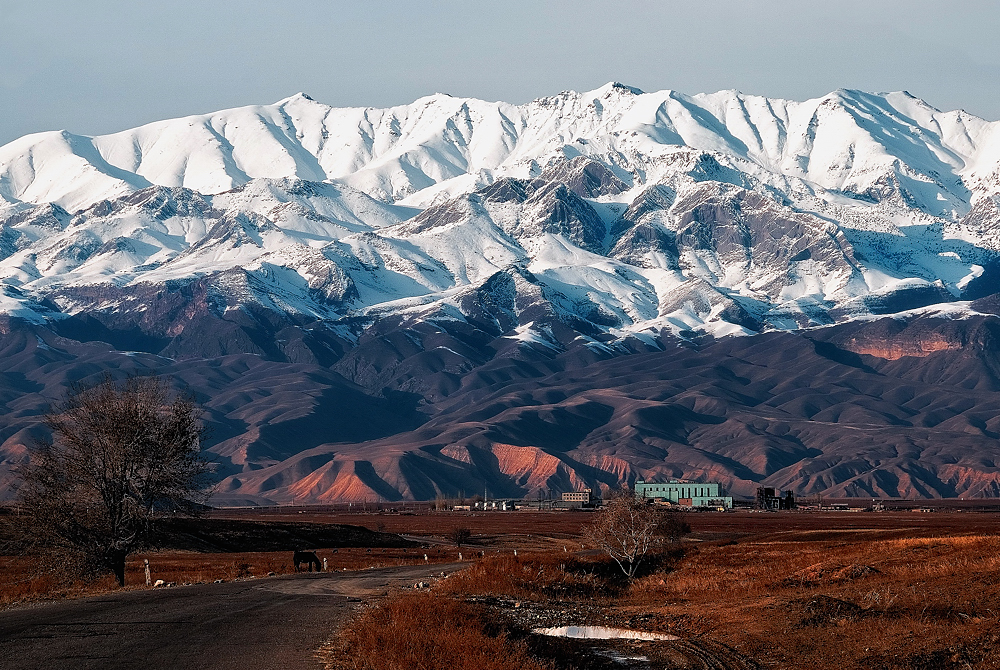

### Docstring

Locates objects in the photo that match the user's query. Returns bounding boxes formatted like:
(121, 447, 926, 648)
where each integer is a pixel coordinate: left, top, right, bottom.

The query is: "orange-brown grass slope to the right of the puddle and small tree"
(621, 535, 1000, 670)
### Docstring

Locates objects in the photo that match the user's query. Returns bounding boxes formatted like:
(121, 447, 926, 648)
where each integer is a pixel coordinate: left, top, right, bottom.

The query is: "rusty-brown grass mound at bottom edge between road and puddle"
(328, 593, 545, 670)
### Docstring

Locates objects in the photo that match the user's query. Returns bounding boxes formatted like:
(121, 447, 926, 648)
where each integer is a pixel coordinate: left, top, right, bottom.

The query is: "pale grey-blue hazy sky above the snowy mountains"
(0, 0, 1000, 144)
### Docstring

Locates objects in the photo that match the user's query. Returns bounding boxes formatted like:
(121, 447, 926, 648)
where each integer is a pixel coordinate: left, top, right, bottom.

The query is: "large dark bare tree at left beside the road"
(19, 375, 208, 585)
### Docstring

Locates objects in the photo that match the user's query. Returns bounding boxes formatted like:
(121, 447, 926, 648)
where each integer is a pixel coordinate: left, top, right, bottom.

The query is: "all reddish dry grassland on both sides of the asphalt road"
(0, 510, 1000, 670)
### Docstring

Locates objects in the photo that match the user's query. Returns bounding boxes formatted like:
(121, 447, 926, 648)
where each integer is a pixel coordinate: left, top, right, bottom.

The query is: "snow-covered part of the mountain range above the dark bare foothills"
(0, 84, 1000, 338)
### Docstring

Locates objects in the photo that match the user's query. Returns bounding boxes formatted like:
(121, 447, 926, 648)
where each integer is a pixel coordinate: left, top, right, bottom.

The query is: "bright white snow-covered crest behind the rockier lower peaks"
(0, 83, 1000, 215)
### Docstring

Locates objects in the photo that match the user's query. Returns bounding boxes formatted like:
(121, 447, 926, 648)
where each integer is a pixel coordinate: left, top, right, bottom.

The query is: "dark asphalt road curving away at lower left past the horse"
(0, 564, 462, 670)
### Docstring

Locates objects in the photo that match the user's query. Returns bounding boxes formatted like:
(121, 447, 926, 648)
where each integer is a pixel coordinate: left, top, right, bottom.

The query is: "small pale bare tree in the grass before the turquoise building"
(583, 489, 690, 579)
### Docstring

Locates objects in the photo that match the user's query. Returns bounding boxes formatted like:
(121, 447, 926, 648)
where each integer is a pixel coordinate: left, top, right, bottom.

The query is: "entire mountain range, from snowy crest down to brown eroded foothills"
(0, 82, 1000, 502)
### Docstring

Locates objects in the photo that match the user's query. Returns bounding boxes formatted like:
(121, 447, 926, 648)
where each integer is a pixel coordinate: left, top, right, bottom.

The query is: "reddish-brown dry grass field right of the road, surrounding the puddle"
(316, 512, 1000, 670)
